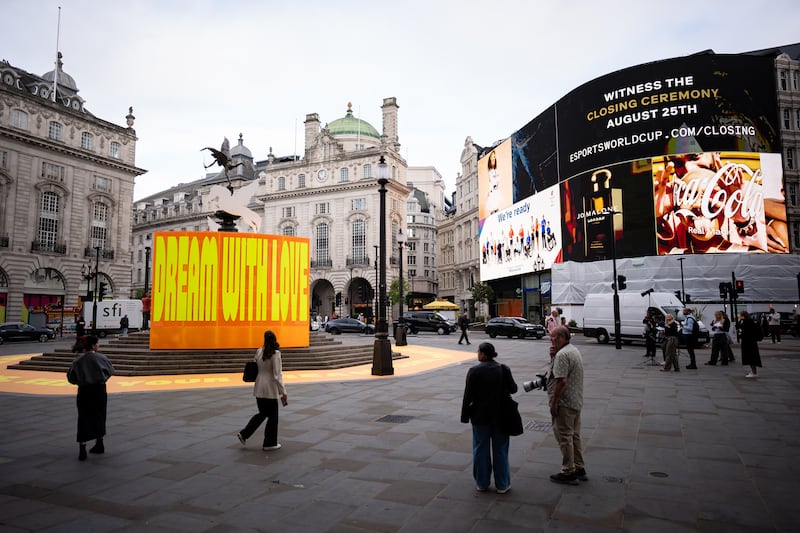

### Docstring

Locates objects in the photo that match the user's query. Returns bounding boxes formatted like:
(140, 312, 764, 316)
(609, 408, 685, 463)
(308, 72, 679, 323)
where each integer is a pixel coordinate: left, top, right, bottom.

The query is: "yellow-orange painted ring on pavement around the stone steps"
(0, 345, 476, 395)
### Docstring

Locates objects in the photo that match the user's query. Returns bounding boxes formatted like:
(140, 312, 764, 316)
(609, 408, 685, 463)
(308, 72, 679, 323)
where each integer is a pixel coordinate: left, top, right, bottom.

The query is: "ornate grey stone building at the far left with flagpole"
(0, 56, 145, 327)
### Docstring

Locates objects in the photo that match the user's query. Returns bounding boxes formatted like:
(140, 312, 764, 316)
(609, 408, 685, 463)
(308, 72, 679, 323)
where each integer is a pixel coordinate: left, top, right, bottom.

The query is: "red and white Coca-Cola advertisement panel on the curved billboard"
(652, 152, 789, 254)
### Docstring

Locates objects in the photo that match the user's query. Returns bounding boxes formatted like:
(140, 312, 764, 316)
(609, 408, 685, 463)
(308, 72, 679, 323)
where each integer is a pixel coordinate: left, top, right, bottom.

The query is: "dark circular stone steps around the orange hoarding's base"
(8, 332, 403, 376)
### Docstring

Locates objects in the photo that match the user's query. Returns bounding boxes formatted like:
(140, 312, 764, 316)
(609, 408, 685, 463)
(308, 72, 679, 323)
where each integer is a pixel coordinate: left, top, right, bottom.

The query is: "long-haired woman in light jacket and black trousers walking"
(236, 330, 288, 451)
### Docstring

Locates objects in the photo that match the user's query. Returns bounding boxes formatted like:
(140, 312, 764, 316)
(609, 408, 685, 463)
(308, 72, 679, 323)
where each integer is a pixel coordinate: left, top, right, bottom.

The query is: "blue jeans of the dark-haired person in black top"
(472, 424, 511, 490)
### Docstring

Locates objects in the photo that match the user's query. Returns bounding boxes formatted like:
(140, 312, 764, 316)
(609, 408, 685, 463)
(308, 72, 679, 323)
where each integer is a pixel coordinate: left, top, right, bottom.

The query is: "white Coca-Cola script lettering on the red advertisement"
(672, 163, 764, 219)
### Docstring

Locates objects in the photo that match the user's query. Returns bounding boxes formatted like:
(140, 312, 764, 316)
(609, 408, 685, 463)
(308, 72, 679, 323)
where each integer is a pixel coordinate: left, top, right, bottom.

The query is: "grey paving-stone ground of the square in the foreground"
(0, 333, 800, 533)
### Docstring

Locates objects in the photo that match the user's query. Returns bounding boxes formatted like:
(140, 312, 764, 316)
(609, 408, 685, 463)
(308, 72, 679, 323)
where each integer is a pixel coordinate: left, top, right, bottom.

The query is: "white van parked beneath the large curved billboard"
(583, 292, 709, 345)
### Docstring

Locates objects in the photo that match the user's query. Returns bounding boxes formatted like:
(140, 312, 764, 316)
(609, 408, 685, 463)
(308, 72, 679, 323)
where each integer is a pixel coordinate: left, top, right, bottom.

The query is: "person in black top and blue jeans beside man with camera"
(461, 342, 517, 494)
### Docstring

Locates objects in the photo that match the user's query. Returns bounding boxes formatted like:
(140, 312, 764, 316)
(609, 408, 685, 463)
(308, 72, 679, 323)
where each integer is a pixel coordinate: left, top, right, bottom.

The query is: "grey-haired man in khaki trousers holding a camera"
(547, 326, 588, 485)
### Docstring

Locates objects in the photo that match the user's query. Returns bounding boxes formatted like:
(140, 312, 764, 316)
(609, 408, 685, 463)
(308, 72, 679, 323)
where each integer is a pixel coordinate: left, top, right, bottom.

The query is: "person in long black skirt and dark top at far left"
(67, 335, 114, 461)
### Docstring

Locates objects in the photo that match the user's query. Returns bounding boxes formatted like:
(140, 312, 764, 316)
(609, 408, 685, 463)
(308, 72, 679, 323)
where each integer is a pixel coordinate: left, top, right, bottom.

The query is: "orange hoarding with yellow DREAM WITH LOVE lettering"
(150, 231, 310, 349)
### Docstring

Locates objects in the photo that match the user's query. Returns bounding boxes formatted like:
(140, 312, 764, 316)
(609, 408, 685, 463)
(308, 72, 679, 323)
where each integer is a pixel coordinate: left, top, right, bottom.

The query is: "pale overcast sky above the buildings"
(0, 0, 800, 198)
